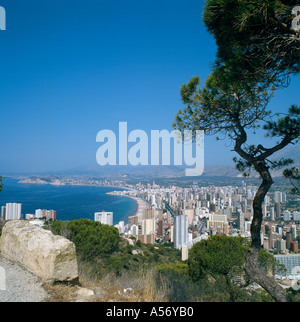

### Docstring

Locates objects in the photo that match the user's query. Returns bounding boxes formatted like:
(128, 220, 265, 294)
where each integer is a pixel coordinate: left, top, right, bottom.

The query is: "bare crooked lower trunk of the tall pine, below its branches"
(245, 162, 291, 302)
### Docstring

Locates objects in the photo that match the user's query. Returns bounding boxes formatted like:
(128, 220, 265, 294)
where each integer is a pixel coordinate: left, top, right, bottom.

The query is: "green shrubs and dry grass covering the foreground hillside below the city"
(41, 219, 296, 302)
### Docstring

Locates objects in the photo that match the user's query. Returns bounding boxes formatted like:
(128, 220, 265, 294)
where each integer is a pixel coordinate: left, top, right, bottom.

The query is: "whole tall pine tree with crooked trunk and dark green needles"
(174, 0, 300, 302)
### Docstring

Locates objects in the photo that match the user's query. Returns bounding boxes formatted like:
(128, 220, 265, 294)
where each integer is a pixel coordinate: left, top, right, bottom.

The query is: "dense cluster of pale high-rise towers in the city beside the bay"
(111, 182, 300, 272)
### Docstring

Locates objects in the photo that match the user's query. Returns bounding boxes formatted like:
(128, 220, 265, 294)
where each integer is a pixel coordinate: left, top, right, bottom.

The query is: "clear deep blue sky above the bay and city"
(0, 0, 300, 173)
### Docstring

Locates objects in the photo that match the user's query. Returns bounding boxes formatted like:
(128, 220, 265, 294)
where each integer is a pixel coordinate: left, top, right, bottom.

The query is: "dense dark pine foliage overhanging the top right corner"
(203, 0, 300, 88)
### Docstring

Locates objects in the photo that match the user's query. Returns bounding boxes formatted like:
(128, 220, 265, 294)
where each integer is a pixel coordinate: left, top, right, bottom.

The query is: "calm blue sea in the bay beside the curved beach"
(0, 177, 137, 225)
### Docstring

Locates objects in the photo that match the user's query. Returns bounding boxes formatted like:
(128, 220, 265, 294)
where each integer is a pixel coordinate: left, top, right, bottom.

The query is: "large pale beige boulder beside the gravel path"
(0, 220, 78, 283)
